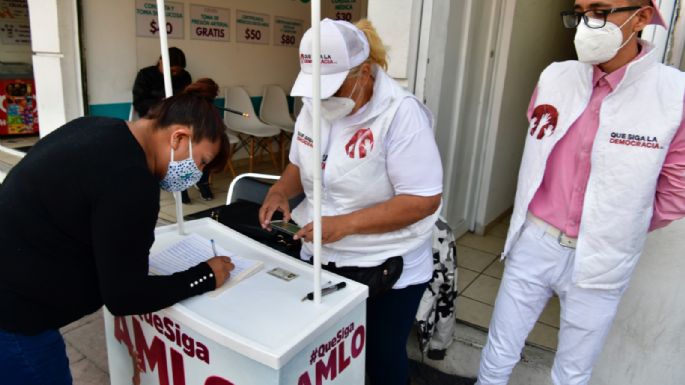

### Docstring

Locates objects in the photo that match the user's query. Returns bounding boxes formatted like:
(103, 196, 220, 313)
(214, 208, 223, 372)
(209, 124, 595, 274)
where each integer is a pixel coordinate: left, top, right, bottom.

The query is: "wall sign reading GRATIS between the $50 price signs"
(190, 4, 231, 41)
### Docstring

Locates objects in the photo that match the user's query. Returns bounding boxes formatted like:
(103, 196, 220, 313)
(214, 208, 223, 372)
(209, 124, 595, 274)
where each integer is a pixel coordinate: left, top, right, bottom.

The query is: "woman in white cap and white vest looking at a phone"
(259, 19, 442, 385)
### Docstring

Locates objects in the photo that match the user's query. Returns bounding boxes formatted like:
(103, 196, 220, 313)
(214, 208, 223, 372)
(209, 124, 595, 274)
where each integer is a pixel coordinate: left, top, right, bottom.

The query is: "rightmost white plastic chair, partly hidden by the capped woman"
(259, 85, 295, 170)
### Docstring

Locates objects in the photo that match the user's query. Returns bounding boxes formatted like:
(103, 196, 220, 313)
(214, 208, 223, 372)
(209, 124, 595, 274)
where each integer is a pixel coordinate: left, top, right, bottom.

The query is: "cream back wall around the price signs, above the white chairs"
(82, 0, 310, 105)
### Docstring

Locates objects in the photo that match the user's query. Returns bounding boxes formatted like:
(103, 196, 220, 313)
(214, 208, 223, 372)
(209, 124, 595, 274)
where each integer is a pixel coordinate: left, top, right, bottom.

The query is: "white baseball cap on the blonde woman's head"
(290, 19, 369, 99)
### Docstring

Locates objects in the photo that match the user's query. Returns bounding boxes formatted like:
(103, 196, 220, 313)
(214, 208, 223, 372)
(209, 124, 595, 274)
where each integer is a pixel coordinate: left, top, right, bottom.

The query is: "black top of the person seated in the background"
(133, 65, 192, 117)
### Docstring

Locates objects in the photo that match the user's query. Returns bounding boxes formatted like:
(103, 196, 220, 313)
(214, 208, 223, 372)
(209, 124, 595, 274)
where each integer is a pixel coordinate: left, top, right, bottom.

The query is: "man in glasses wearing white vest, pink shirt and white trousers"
(477, 0, 685, 385)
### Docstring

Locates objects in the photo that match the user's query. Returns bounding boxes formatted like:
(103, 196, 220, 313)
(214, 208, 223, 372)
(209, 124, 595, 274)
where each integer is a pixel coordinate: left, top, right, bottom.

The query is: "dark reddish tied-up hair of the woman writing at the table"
(146, 78, 229, 171)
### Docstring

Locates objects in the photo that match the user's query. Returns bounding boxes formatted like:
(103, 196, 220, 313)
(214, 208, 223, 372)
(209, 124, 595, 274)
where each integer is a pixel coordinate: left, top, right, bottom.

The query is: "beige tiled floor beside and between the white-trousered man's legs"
(456, 216, 559, 350)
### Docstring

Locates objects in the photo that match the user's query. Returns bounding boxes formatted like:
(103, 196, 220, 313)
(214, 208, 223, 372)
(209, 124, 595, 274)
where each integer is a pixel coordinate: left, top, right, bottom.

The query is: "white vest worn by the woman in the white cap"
(292, 68, 439, 266)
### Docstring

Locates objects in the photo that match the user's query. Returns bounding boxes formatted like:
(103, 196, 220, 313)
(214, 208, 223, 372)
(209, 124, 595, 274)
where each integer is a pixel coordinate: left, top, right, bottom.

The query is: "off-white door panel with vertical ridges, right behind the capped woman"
(417, 0, 515, 235)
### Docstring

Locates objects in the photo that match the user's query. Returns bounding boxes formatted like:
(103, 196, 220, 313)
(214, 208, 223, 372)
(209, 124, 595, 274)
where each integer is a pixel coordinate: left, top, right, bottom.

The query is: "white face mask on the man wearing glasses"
(574, 10, 640, 64)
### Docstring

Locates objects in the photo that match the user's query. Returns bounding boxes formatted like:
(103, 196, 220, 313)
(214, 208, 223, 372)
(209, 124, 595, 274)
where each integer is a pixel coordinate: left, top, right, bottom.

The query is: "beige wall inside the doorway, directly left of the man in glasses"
(476, 0, 574, 232)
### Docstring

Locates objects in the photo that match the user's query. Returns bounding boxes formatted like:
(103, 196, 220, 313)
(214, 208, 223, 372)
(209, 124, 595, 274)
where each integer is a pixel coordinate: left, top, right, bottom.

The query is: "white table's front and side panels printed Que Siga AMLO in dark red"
(104, 303, 366, 385)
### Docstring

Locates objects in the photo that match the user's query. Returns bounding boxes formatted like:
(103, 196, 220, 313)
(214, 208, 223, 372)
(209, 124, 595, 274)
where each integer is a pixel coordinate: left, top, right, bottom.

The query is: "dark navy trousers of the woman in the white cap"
(366, 283, 428, 385)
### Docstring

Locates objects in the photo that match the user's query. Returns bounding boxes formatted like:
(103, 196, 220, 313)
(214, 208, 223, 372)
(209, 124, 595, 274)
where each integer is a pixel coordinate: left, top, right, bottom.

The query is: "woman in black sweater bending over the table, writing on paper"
(0, 79, 233, 385)
